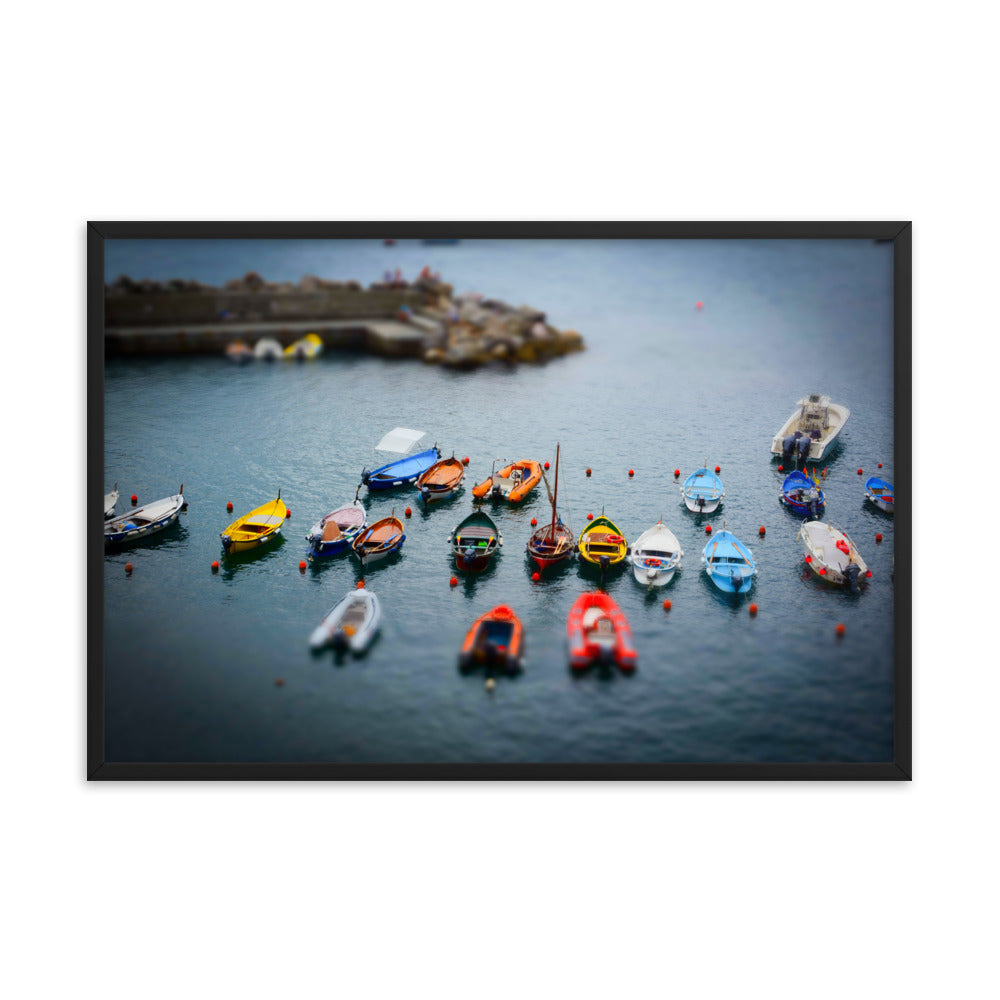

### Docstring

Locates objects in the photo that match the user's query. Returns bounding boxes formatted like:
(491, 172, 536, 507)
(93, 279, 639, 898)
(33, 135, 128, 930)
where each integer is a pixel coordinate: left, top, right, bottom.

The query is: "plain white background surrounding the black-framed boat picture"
(0, 2, 998, 1000)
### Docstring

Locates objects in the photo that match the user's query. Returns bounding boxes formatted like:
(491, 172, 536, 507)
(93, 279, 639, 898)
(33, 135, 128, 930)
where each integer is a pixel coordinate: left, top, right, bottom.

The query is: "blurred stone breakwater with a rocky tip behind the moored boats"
(104, 272, 584, 368)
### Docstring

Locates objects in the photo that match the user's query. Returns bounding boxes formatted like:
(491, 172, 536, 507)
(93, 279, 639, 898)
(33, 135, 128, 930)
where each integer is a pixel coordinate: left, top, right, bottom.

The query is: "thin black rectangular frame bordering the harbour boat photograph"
(86, 221, 913, 781)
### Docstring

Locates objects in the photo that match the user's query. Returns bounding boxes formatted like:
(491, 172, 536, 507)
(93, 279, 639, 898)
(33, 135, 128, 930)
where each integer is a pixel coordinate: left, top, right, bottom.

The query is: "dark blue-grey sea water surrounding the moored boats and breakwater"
(104, 240, 893, 762)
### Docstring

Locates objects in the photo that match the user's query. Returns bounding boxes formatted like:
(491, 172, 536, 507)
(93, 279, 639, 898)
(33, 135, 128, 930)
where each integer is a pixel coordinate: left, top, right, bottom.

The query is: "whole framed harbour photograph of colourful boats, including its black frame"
(87, 222, 912, 780)
